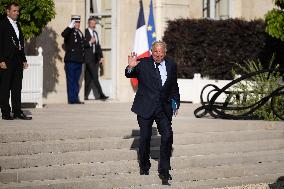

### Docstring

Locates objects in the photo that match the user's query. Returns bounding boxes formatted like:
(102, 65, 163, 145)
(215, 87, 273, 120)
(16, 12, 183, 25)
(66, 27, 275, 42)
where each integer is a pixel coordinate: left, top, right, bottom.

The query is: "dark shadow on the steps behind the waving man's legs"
(124, 127, 161, 164)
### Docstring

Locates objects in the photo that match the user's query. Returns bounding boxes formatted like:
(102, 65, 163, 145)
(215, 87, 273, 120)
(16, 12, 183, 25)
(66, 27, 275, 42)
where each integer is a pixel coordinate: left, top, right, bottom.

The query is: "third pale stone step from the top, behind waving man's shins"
(0, 139, 284, 169)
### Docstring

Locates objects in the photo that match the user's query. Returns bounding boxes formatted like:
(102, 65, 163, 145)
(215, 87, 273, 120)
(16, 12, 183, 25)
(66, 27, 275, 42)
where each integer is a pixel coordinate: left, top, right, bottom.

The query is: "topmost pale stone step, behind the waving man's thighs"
(0, 119, 284, 143)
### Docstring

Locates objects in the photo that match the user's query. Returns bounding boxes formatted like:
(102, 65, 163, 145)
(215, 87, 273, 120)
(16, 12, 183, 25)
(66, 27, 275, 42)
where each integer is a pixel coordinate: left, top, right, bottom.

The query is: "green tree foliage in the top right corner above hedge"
(265, 0, 284, 41)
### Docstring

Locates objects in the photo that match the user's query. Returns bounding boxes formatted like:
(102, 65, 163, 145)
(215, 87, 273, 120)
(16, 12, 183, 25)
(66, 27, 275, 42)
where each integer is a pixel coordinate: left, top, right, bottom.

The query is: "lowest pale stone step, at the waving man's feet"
(0, 162, 284, 189)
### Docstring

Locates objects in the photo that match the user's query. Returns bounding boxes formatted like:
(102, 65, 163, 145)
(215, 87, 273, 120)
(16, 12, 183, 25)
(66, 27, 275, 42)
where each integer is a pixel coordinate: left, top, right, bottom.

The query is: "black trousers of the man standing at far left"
(0, 58, 23, 115)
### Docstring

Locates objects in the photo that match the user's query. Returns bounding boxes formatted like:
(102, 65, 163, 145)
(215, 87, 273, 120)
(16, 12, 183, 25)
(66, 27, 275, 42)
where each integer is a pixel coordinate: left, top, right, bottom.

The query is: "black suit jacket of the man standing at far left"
(0, 17, 27, 63)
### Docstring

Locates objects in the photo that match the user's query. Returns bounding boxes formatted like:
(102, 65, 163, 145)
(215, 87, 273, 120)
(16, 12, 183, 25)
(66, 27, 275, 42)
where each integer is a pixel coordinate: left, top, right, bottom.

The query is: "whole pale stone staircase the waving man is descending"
(0, 103, 284, 189)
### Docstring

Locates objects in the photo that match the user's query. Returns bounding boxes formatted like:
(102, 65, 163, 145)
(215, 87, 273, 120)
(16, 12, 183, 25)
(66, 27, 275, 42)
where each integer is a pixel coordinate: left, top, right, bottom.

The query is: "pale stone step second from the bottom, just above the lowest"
(0, 150, 284, 183)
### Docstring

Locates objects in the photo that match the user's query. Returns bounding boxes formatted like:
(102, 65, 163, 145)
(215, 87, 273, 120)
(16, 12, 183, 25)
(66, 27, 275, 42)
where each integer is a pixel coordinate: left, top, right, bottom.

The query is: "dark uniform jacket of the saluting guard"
(61, 27, 88, 63)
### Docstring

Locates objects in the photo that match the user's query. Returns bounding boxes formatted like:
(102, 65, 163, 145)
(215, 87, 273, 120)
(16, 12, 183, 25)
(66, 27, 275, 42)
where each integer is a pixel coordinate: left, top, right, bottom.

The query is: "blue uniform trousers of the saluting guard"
(65, 62, 82, 103)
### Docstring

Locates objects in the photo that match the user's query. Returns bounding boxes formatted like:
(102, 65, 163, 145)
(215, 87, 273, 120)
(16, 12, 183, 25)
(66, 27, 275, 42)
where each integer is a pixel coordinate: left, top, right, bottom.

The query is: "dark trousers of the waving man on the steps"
(137, 105, 173, 171)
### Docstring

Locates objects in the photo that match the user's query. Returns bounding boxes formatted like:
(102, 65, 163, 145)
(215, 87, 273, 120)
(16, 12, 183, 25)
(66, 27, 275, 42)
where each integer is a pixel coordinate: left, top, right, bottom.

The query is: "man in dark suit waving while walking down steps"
(125, 41, 180, 183)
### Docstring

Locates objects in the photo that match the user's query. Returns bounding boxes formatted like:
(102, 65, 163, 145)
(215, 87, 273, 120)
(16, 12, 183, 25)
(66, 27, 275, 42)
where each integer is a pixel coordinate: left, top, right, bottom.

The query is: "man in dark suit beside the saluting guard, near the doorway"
(85, 17, 108, 100)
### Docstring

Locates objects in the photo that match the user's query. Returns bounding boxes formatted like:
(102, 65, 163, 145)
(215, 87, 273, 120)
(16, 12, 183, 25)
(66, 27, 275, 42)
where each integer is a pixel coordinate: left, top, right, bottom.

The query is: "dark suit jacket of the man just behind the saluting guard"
(85, 28, 103, 64)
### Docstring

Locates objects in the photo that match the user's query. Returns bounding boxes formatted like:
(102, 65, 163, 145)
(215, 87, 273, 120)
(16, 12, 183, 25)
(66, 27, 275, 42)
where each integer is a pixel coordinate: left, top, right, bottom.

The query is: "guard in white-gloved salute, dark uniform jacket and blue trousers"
(61, 15, 92, 104)
